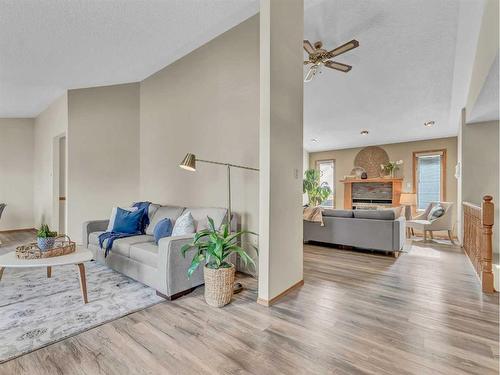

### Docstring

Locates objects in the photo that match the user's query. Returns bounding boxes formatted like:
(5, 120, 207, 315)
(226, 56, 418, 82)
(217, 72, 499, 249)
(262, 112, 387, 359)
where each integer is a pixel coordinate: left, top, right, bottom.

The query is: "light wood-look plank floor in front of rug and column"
(0, 234, 499, 375)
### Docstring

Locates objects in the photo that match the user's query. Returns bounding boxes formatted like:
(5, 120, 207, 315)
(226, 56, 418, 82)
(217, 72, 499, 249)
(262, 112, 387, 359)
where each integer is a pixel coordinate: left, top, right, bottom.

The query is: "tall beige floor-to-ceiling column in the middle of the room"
(258, 0, 304, 305)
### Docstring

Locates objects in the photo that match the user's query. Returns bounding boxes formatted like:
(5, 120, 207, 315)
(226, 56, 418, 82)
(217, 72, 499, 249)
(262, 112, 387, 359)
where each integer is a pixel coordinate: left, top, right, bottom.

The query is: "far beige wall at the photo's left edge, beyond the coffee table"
(0, 118, 34, 231)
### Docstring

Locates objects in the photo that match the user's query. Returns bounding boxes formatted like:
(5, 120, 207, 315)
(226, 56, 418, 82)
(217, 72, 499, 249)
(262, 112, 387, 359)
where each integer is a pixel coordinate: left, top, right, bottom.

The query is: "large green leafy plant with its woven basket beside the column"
(181, 217, 257, 307)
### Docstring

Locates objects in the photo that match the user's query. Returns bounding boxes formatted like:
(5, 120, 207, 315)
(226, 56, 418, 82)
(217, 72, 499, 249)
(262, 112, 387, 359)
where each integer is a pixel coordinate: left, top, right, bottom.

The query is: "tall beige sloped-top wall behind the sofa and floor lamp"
(140, 16, 259, 274)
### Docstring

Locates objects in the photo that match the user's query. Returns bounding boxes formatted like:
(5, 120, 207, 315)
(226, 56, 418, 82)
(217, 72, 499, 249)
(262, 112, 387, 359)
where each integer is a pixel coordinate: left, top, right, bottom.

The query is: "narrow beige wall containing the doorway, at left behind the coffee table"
(34, 94, 68, 228)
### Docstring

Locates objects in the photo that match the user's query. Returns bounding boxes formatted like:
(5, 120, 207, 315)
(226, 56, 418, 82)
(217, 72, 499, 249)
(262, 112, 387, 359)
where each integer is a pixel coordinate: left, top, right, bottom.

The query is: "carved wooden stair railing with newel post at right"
(462, 195, 495, 293)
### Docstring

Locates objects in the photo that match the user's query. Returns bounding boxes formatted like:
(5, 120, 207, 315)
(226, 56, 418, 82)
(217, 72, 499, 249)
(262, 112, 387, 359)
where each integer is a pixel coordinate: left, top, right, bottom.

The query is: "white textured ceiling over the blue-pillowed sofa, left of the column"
(0, 0, 259, 117)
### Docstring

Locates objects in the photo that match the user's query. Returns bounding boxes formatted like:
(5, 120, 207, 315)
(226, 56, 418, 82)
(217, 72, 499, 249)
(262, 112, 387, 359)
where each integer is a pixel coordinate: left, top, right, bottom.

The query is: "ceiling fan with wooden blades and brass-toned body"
(304, 39, 359, 82)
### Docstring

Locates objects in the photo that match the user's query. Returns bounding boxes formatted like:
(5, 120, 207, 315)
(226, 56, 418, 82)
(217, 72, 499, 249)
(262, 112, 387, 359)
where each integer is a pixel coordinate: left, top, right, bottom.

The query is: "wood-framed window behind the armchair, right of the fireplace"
(413, 150, 446, 210)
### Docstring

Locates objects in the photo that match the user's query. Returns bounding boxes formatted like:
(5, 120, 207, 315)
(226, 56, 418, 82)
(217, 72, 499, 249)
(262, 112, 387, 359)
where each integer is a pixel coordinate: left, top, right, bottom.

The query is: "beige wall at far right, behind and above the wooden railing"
(462, 121, 500, 253)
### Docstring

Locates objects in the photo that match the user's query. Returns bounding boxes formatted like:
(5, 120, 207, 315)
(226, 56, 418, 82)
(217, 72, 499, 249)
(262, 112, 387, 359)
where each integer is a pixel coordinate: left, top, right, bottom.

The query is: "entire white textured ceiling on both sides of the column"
(0, 0, 482, 151)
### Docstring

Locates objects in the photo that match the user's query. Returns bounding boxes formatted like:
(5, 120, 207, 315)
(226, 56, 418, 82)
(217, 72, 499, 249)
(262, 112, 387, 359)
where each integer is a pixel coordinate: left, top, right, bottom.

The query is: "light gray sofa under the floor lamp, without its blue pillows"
(83, 204, 237, 300)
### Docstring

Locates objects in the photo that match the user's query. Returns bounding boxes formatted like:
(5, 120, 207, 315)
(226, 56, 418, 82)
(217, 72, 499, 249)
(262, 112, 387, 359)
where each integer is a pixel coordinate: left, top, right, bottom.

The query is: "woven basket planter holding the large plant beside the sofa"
(204, 264, 235, 307)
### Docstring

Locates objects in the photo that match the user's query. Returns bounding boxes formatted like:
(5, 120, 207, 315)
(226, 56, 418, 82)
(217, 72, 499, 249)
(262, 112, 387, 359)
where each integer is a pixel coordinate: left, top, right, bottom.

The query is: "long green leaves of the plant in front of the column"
(181, 217, 257, 277)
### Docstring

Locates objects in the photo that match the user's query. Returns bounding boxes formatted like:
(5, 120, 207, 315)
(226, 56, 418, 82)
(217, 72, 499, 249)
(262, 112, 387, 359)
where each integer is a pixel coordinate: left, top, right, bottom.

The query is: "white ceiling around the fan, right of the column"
(304, 0, 482, 151)
